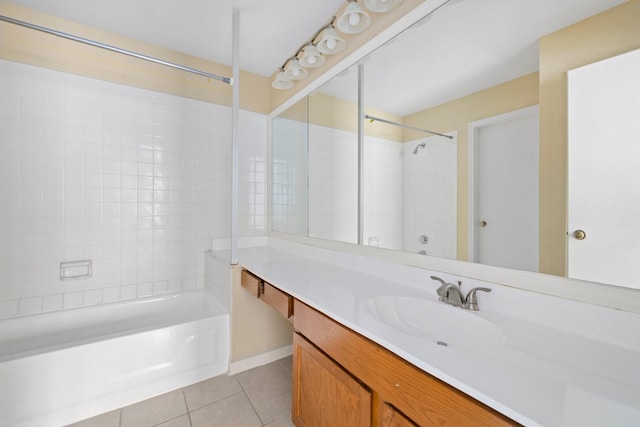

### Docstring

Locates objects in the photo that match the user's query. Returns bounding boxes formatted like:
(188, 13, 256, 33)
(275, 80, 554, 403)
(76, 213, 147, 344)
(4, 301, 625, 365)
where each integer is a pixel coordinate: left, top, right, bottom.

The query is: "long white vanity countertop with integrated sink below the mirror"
(239, 245, 640, 426)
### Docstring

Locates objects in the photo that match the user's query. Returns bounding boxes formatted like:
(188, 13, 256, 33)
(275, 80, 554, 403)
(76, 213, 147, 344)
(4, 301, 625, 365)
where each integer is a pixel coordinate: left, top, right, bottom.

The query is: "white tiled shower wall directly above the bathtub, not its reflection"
(0, 61, 267, 317)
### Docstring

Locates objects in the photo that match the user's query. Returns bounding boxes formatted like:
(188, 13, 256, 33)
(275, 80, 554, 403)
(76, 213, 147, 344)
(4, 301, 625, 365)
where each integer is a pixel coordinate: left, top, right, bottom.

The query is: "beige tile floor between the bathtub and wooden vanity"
(69, 357, 293, 427)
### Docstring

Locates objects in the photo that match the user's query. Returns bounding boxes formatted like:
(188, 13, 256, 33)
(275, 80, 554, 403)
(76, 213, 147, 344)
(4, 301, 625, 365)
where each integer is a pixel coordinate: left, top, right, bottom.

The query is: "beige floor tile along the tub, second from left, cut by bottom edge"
(121, 390, 187, 427)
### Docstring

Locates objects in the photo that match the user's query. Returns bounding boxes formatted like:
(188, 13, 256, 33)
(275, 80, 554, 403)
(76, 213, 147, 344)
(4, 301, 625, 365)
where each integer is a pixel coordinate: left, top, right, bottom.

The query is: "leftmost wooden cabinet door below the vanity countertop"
(293, 333, 371, 427)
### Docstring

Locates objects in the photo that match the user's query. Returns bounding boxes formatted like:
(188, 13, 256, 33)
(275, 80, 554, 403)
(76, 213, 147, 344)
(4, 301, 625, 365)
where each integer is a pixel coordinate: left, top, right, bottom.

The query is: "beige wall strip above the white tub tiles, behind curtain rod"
(0, 2, 270, 114)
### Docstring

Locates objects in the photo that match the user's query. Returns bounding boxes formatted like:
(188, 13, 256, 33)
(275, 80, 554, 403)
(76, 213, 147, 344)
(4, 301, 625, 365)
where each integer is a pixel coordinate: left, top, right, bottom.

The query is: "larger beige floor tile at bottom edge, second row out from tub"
(190, 393, 262, 427)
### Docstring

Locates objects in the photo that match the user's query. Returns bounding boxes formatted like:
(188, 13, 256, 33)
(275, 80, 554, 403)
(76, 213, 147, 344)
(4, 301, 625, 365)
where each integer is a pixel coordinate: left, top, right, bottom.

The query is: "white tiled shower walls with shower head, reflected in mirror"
(272, 118, 457, 259)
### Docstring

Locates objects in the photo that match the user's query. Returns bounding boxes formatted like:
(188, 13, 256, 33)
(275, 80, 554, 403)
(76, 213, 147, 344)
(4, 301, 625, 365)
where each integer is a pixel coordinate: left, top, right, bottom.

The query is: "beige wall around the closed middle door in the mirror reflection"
(404, 73, 538, 260)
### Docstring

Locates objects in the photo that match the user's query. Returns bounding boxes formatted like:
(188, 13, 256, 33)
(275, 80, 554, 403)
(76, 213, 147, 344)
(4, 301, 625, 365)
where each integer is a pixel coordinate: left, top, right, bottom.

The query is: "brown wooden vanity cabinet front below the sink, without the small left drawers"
(293, 300, 518, 427)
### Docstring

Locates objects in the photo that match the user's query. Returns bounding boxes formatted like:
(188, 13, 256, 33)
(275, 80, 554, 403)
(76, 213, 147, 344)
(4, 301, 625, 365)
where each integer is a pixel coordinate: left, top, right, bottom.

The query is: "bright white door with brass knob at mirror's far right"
(567, 50, 640, 288)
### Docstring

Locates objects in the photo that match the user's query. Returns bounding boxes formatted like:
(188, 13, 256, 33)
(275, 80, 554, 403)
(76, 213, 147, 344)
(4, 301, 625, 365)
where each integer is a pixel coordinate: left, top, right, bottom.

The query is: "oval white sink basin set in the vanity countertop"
(364, 296, 506, 351)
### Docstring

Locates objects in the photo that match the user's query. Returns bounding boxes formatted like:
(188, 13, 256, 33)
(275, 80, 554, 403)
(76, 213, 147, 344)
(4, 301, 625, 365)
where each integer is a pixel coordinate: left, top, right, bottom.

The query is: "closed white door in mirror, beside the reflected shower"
(471, 107, 539, 271)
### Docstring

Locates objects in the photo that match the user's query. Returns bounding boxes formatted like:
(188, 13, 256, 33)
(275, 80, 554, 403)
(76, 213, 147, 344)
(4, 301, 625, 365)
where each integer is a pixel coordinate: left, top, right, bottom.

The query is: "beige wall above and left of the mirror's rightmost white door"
(540, 0, 640, 276)
